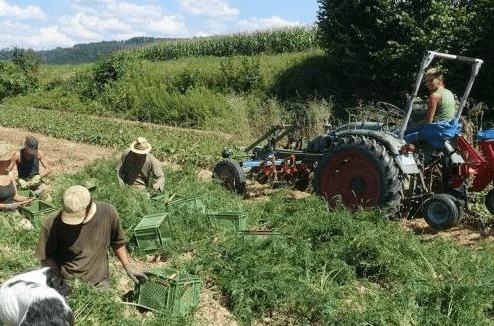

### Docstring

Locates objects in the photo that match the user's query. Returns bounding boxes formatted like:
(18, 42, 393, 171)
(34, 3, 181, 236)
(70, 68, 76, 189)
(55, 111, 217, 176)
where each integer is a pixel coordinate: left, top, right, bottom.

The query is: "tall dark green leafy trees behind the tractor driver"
(318, 0, 493, 107)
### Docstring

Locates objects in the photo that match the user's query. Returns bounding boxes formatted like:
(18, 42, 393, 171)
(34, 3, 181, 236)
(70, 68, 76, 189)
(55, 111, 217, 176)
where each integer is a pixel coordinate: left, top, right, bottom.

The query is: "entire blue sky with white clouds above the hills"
(0, 0, 318, 50)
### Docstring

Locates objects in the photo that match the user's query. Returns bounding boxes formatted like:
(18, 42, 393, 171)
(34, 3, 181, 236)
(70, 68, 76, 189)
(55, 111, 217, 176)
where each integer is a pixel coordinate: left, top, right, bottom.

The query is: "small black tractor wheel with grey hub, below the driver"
(422, 194, 460, 229)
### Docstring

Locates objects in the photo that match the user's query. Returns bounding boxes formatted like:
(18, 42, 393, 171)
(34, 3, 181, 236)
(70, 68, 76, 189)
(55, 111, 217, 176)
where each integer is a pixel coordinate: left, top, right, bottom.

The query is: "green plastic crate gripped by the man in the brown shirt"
(134, 268, 202, 316)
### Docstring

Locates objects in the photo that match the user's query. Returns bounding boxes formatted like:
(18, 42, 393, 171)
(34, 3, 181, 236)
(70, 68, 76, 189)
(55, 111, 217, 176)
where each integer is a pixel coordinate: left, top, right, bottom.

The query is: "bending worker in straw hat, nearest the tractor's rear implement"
(117, 137, 165, 191)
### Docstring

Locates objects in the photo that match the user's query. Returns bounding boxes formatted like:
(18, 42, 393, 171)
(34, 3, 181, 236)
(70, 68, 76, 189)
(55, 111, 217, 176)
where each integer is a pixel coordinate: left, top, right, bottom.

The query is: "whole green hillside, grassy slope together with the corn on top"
(0, 29, 331, 144)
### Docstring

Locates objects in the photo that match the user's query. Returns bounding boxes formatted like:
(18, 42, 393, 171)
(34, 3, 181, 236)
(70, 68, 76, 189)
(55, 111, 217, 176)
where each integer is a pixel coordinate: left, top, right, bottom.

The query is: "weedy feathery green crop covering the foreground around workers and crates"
(0, 152, 494, 326)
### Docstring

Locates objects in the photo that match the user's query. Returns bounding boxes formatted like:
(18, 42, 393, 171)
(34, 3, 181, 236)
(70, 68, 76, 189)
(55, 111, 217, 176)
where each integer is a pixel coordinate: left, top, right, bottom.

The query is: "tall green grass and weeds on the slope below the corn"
(3, 50, 331, 142)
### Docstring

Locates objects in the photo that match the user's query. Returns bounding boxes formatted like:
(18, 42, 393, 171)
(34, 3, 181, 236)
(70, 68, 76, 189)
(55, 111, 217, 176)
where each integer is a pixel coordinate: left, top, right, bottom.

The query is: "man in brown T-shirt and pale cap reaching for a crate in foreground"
(36, 186, 147, 287)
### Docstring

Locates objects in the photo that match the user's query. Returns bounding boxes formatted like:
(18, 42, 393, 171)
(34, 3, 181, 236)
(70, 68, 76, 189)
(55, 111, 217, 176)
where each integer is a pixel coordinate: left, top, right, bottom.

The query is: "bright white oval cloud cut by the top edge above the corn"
(180, 0, 240, 19)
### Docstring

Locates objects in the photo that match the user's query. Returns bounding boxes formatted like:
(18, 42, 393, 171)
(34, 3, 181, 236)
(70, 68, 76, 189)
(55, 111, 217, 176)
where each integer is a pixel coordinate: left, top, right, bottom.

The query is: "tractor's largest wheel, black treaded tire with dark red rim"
(313, 135, 402, 210)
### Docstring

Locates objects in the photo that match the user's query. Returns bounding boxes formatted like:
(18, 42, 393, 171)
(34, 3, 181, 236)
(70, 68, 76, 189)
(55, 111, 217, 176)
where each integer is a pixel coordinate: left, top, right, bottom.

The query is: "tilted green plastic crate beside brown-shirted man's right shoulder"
(134, 213, 171, 252)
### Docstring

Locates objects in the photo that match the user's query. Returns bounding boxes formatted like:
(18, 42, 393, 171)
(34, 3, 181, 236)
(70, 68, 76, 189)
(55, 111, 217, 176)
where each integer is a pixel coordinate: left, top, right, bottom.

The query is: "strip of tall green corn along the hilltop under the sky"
(140, 27, 319, 60)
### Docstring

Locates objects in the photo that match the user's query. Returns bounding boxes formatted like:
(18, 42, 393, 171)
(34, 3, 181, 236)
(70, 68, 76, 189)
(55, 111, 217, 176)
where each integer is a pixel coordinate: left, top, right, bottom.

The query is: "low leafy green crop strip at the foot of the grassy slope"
(0, 105, 232, 167)
